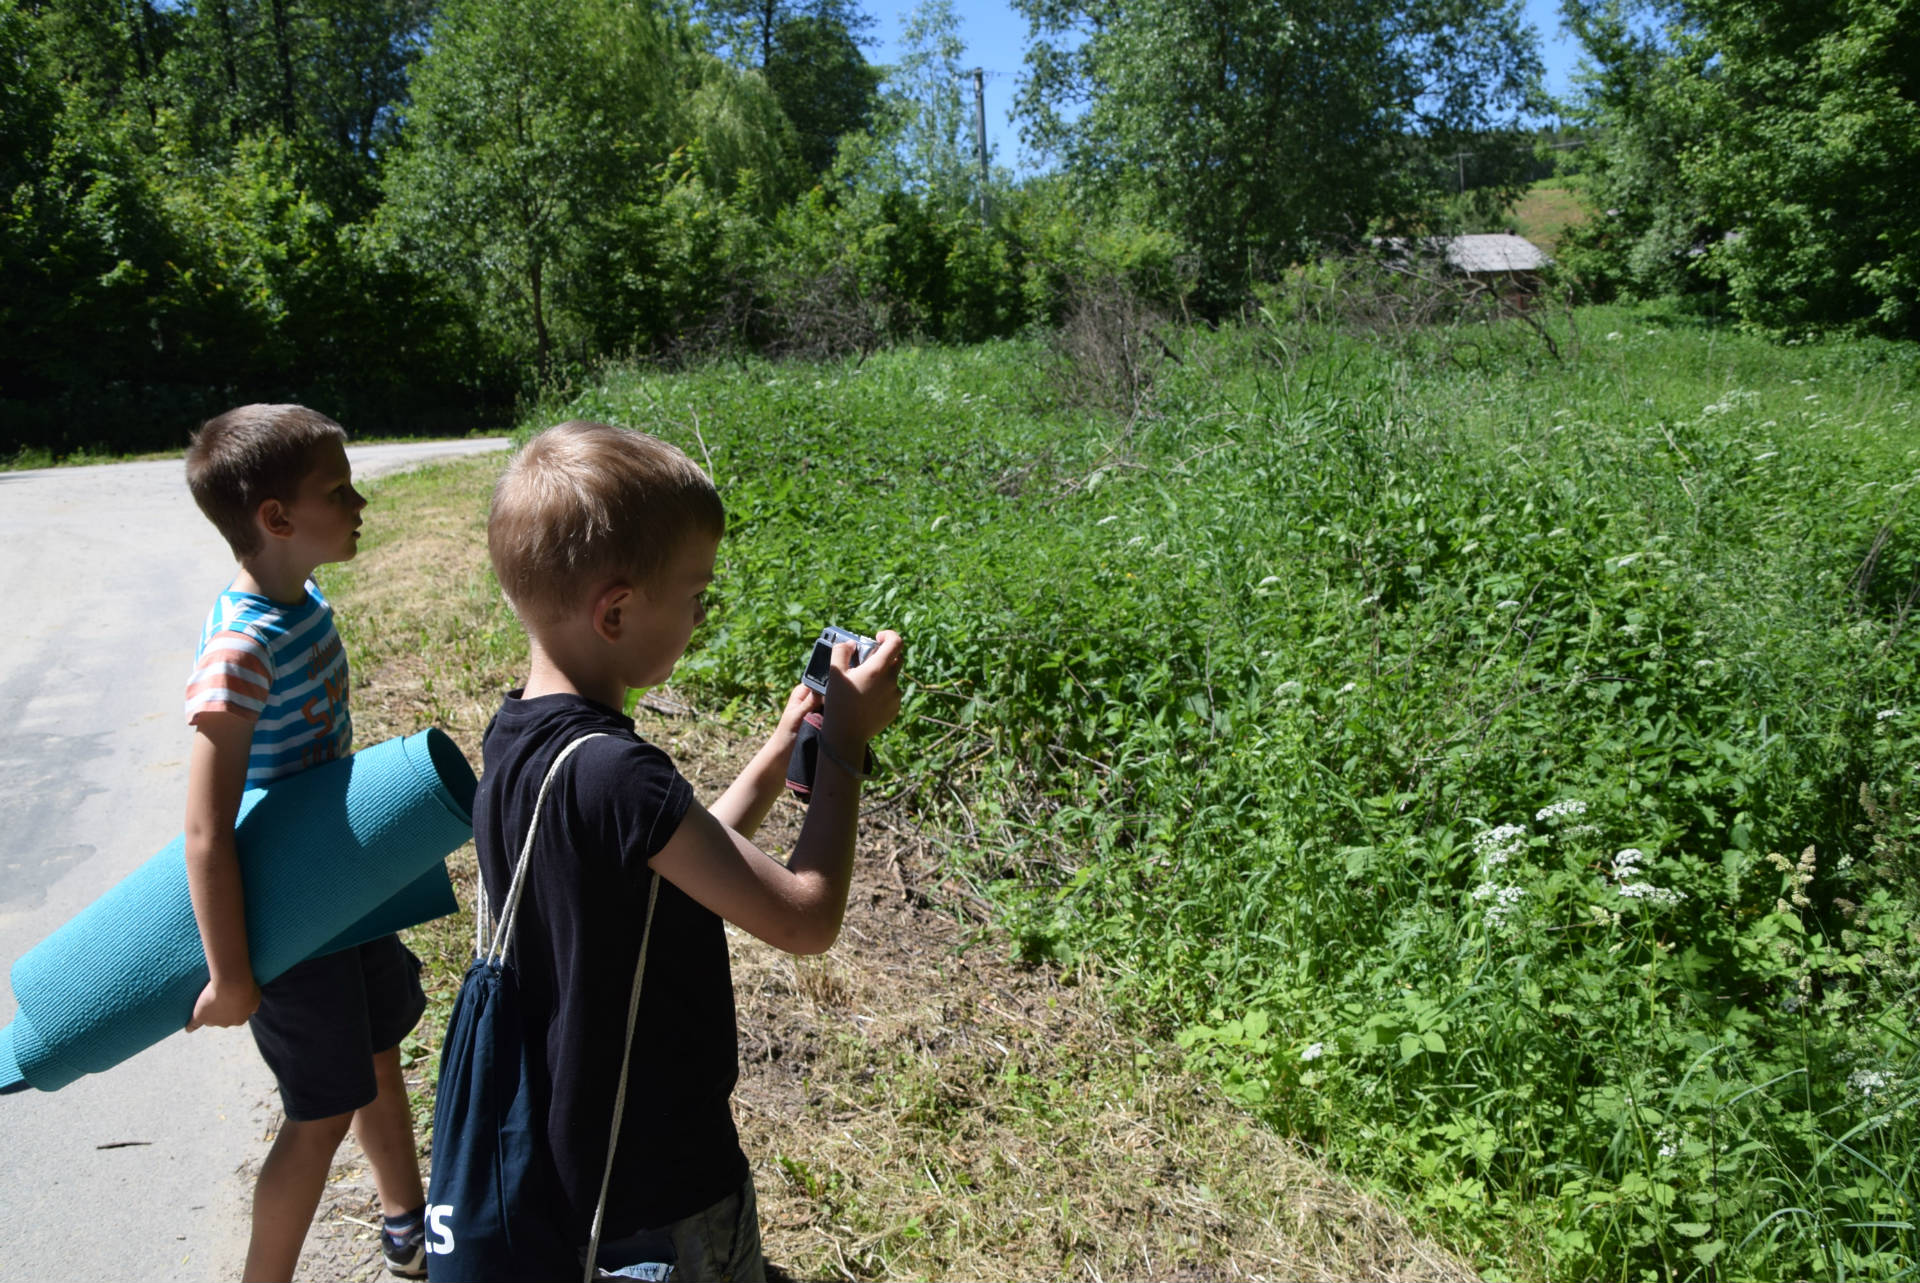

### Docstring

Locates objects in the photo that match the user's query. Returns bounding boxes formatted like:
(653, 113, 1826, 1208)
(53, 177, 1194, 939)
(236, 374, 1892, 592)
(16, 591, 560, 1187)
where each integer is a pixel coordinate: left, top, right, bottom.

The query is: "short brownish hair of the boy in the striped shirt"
(186, 405, 348, 557)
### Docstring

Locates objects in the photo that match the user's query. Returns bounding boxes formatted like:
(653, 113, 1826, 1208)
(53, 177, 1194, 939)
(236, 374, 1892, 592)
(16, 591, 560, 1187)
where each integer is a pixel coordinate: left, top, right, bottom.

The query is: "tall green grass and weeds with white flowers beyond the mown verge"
(518, 309, 1920, 1279)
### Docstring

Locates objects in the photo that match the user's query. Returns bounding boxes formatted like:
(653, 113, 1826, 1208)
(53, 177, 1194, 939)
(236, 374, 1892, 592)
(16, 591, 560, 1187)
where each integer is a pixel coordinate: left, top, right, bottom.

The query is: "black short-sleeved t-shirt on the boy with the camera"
(474, 691, 747, 1243)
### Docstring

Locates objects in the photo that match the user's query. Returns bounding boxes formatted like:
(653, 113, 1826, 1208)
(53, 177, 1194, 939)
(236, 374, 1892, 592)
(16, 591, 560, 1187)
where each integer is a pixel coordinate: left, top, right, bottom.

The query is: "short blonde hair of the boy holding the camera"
(486, 419, 726, 624)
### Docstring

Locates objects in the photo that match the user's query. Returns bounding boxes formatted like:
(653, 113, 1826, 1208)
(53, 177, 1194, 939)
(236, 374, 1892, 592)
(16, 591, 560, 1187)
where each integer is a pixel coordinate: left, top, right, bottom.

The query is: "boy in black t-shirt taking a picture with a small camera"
(458, 423, 902, 1283)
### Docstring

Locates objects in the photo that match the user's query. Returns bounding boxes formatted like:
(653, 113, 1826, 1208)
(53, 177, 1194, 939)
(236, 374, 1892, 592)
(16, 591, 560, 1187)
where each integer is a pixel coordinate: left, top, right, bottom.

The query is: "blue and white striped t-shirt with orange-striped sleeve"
(186, 580, 353, 787)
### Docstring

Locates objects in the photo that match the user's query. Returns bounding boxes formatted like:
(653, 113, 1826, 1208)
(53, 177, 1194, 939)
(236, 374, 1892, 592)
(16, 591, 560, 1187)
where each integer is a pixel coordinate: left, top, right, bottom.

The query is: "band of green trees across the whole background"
(0, 0, 1920, 451)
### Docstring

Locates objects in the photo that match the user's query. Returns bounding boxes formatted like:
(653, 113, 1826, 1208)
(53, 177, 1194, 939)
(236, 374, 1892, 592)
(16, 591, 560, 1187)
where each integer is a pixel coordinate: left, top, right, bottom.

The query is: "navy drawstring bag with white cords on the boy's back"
(426, 736, 660, 1283)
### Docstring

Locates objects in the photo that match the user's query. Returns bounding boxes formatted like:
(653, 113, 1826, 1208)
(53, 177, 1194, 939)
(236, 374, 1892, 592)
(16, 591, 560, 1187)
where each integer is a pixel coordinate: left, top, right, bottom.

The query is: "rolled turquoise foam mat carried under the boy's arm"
(0, 730, 474, 1093)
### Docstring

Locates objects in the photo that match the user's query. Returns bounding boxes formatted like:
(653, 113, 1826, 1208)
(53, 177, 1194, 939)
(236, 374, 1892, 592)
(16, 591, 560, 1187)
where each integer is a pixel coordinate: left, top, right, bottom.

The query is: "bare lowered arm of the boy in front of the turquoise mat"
(186, 711, 259, 1029)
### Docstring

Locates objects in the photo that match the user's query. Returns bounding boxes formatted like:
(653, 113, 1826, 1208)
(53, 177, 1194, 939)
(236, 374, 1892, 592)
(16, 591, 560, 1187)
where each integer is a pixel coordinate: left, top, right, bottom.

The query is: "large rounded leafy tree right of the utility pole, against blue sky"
(1018, 0, 1540, 300)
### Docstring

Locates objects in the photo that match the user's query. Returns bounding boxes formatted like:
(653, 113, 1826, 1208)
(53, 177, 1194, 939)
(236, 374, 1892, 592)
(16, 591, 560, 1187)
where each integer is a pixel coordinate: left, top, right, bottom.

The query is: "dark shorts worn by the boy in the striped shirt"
(248, 935, 426, 1122)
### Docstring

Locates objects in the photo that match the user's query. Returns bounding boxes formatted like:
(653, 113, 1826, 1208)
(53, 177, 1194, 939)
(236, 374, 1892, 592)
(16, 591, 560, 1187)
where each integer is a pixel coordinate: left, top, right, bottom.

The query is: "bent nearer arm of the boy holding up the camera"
(653, 632, 900, 953)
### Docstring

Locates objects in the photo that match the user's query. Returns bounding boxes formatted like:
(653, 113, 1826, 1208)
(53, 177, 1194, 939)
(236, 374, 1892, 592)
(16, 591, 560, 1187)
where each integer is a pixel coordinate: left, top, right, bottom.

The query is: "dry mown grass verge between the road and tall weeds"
(288, 457, 1475, 1279)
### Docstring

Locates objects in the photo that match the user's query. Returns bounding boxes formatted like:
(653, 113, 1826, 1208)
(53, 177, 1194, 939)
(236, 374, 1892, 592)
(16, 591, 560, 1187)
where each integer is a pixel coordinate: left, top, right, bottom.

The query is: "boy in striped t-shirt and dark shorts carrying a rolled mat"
(186, 405, 426, 1279)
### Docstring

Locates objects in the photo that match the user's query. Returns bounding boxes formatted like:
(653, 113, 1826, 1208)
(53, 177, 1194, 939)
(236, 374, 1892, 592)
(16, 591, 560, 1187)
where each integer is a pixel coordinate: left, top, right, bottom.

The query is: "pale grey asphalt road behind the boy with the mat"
(0, 438, 507, 1281)
